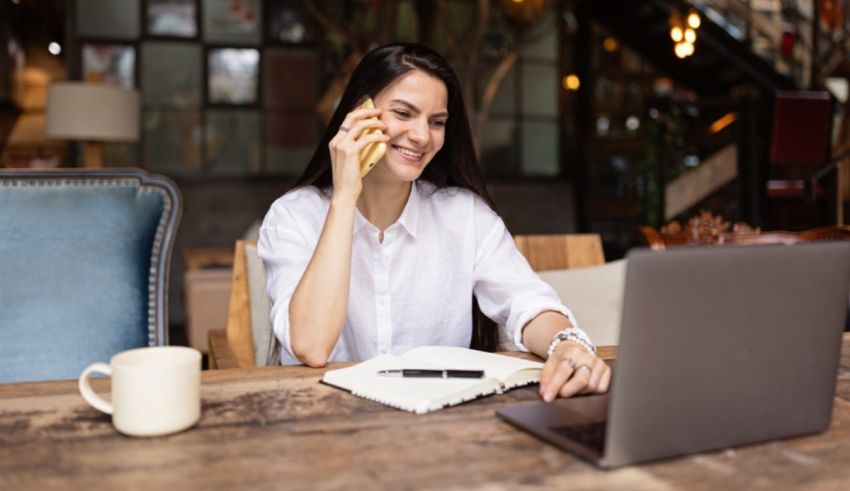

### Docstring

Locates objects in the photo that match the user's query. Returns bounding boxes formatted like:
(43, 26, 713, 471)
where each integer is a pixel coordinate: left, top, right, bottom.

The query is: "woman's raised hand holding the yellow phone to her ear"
(328, 104, 389, 200)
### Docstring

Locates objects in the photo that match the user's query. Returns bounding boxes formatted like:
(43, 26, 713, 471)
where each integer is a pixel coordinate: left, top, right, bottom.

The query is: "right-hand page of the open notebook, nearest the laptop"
(401, 346, 543, 382)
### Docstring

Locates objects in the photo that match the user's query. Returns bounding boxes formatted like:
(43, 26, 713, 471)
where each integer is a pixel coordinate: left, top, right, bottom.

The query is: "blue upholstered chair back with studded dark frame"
(0, 169, 181, 383)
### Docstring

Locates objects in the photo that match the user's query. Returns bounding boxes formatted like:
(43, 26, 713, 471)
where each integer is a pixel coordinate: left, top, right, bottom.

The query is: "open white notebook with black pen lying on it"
(322, 346, 543, 414)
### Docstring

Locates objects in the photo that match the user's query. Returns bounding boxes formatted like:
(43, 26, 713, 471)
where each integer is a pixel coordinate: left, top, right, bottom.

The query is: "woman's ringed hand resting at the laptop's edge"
(540, 341, 611, 402)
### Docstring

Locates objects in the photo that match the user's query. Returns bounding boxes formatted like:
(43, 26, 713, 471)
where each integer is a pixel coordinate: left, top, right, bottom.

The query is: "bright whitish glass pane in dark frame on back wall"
(208, 48, 260, 104)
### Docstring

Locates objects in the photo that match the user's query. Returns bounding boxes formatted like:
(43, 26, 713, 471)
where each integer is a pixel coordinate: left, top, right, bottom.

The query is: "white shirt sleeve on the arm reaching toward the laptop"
(473, 199, 589, 351)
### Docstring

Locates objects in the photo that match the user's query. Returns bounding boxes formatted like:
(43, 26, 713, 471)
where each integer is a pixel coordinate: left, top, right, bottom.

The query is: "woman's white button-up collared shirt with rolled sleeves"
(257, 182, 578, 364)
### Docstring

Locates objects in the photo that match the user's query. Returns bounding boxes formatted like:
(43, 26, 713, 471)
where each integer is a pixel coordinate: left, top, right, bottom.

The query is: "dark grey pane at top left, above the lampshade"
(76, 0, 141, 39)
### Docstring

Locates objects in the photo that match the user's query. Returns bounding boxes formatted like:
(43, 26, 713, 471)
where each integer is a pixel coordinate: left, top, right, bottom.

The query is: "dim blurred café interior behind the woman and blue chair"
(0, 0, 850, 347)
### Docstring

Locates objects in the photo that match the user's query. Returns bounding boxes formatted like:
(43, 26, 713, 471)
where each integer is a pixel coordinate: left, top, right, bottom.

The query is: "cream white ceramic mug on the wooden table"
(79, 346, 201, 436)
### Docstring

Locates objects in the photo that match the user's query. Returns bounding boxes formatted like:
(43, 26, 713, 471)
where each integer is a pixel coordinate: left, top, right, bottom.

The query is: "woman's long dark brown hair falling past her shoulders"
(295, 43, 499, 351)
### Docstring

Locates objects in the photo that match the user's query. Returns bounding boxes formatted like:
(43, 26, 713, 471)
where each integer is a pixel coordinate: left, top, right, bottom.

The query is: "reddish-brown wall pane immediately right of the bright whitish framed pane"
(263, 49, 319, 110)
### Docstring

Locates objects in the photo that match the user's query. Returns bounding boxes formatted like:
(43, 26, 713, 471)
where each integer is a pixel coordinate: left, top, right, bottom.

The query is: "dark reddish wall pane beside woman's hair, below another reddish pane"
(266, 114, 319, 175)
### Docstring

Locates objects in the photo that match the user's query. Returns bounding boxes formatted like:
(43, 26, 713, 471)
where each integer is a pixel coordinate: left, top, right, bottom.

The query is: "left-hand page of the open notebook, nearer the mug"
(322, 355, 496, 414)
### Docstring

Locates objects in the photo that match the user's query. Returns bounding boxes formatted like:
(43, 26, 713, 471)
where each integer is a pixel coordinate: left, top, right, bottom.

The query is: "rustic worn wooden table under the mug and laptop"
(0, 335, 850, 490)
